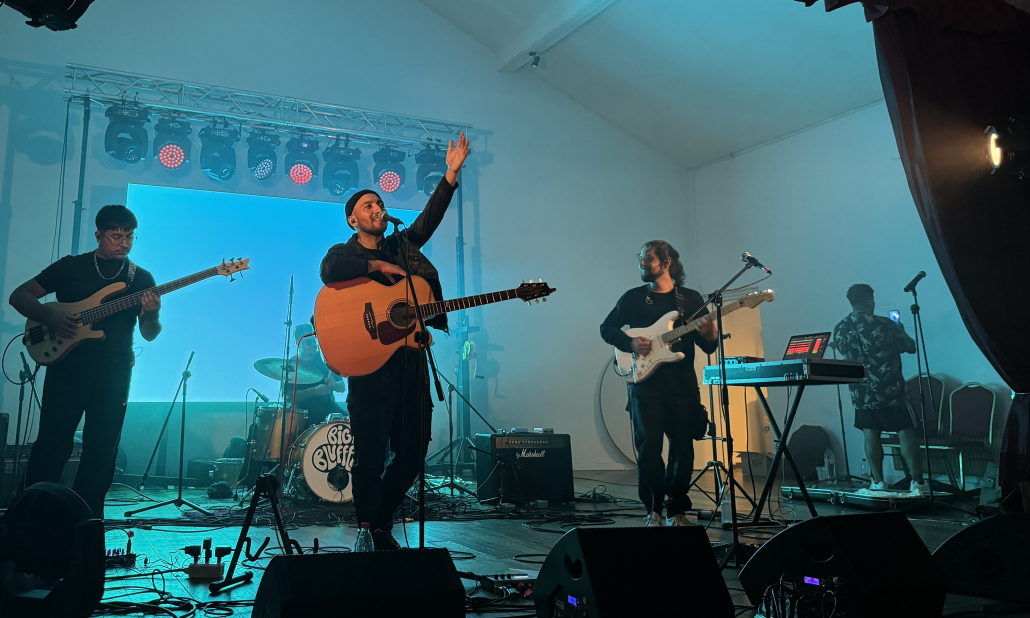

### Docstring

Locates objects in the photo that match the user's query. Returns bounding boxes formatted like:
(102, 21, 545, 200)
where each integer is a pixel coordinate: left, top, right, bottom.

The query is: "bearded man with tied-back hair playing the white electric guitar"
(600, 240, 719, 526)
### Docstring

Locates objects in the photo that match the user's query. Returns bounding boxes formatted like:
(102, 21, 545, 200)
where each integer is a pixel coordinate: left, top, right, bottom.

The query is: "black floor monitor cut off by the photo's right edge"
(933, 513, 1030, 605)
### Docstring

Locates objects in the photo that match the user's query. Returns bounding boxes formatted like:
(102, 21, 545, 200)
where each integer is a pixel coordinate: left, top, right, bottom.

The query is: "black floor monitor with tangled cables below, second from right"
(740, 513, 945, 618)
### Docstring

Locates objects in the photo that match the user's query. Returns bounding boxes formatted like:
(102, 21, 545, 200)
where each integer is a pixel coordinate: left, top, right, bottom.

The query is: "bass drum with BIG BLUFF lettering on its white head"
(285, 420, 354, 504)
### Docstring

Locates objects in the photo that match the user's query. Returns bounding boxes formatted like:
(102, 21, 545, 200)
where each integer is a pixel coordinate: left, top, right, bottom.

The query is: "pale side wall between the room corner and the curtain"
(691, 103, 1009, 474)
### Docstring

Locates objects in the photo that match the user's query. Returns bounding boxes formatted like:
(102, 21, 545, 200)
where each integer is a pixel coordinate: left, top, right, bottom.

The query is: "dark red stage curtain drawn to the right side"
(802, 0, 1030, 502)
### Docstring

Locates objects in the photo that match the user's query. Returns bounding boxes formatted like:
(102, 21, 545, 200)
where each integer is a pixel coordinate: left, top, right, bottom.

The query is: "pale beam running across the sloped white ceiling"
(497, 0, 616, 73)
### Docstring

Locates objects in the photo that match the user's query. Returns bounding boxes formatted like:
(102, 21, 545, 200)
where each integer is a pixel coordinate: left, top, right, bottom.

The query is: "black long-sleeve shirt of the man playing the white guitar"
(600, 285, 719, 392)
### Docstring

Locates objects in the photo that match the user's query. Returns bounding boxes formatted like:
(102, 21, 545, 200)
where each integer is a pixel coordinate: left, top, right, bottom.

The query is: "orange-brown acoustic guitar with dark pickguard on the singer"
(314, 276, 554, 377)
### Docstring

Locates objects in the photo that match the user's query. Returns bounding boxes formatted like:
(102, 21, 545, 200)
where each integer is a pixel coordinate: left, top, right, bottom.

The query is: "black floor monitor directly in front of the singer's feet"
(251, 548, 465, 618)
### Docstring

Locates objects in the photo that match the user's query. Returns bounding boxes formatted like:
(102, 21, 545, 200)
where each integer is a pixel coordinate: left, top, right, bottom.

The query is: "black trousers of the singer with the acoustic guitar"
(347, 350, 433, 529)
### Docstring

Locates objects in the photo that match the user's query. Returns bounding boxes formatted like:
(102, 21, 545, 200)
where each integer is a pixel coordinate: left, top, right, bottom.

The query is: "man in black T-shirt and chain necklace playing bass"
(10, 206, 161, 519)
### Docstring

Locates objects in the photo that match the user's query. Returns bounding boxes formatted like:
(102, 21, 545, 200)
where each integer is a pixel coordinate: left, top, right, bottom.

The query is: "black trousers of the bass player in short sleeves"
(25, 350, 132, 518)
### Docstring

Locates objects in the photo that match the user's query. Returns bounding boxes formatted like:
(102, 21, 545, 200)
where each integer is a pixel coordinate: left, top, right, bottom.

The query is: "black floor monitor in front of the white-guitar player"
(533, 526, 733, 618)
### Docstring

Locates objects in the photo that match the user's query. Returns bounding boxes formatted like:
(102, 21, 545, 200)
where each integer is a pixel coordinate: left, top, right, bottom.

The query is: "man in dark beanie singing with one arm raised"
(321, 133, 469, 550)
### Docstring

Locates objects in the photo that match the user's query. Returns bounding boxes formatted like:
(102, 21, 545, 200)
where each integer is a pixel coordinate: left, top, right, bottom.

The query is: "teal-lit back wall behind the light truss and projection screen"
(0, 0, 695, 468)
